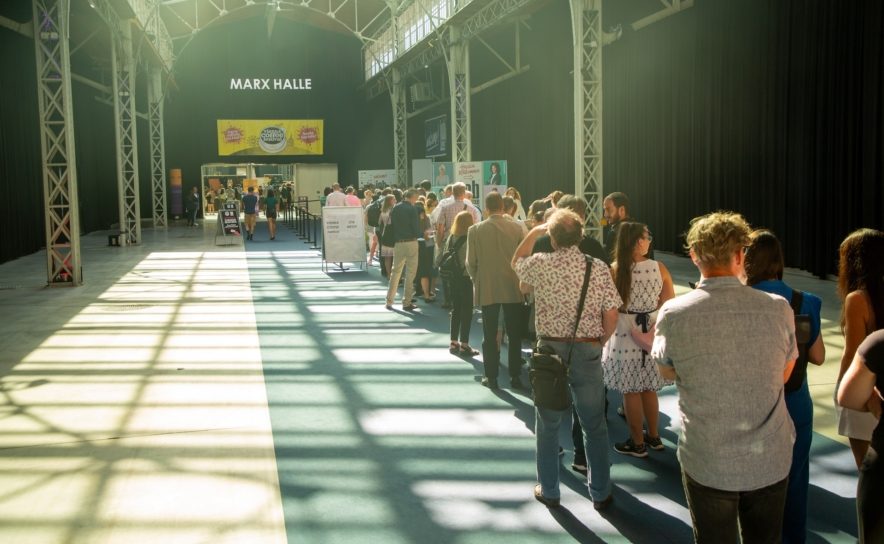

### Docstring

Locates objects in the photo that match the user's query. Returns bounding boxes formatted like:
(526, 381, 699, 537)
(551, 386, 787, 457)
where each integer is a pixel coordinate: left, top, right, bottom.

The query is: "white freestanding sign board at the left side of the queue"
(322, 206, 366, 270)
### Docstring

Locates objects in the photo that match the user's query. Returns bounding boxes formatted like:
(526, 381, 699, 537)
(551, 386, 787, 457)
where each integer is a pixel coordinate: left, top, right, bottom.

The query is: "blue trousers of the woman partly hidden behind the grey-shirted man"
(783, 380, 813, 544)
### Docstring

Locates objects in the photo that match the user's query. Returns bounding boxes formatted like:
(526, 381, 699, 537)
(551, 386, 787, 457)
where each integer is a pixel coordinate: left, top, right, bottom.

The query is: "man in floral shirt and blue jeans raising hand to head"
(512, 209, 623, 510)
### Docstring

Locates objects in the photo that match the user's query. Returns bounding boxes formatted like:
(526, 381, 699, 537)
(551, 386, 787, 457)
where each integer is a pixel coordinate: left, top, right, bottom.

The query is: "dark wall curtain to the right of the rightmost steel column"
(604, 0, 884, 276)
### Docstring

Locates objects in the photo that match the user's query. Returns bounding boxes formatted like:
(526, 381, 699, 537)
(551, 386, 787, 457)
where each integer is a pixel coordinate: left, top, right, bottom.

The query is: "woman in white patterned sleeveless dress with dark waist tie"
(604, 221, 675, 457)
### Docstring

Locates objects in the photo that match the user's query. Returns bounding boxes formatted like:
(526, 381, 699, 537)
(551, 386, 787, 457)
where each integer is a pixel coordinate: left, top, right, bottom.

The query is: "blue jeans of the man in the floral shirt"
(534, 340, 611, 501)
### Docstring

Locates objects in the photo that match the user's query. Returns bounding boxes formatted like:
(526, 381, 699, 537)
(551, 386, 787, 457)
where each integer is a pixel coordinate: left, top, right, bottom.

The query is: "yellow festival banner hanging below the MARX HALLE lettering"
(218, 119, 322, 156)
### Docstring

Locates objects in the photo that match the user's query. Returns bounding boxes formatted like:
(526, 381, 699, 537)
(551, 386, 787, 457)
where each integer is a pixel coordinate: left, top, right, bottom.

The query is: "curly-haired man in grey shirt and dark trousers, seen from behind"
(652, 212, 798, 543)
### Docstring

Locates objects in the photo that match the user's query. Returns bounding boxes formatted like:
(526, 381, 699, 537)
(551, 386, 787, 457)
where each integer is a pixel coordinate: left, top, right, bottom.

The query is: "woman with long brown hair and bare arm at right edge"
(835, 229, 884, 467)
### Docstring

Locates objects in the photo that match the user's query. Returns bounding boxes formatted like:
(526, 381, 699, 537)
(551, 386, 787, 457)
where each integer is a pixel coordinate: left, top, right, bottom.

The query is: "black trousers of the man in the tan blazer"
(482, 302, 525, 380)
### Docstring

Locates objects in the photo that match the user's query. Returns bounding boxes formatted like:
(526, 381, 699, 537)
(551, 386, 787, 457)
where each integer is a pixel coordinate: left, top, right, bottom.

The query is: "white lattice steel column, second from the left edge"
(111, 20, 141, 245)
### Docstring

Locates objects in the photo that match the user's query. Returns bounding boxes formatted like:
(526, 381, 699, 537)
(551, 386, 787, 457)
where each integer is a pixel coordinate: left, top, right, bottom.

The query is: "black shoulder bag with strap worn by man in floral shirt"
(528, 257, 592, 410)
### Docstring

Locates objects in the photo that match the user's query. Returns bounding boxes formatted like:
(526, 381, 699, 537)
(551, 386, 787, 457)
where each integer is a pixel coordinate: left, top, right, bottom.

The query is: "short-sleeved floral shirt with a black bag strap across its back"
(516, 246, 623, 338)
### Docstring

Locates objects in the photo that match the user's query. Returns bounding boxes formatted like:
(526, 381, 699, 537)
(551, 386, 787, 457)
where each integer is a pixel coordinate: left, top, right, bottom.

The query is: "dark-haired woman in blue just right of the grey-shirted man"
(743, 230, 826, 542)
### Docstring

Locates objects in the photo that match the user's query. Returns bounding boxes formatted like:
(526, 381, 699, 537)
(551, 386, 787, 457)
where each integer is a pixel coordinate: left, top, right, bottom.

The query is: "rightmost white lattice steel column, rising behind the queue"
(570, 0, 604, 240)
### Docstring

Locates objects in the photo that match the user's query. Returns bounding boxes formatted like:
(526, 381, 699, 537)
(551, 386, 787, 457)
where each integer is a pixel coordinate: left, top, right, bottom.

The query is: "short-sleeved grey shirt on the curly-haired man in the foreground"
(651, 276, 798, 491)
